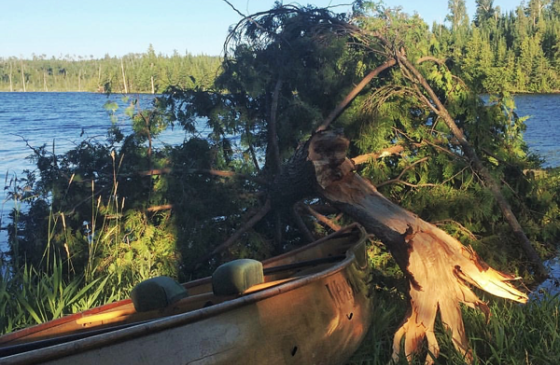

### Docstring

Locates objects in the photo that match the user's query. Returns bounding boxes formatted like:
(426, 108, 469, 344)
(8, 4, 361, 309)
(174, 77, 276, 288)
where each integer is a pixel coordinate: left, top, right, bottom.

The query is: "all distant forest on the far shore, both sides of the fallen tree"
(0, 0, 560, 93)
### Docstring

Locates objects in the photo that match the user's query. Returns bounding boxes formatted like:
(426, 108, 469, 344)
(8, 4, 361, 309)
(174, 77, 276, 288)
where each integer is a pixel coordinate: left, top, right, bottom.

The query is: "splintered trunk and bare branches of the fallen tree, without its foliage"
(194, 2, 544, 363)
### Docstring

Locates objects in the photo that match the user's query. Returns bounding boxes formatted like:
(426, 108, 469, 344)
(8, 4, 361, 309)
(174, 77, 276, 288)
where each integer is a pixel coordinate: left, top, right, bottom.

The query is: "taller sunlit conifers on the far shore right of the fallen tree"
(438, 0, 560, 92)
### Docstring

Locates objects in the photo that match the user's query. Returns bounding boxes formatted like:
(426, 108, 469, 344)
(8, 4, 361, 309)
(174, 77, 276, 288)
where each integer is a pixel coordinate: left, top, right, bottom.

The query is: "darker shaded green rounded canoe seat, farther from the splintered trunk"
(130, 276, 188, 312)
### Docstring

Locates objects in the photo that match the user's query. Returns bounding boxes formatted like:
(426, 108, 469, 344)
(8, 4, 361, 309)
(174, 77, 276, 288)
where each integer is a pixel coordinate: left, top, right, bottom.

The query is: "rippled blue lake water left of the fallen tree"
(0, 93, 189, 251)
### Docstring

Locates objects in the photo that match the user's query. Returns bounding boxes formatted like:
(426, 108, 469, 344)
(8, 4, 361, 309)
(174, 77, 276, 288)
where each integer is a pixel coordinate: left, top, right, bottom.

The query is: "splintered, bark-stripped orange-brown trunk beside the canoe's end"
(308, 132, 528, 364)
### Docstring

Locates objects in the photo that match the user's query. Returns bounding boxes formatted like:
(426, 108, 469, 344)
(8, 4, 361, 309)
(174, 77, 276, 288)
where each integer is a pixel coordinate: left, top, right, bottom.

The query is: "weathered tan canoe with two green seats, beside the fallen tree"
(0, 225, 373, 365)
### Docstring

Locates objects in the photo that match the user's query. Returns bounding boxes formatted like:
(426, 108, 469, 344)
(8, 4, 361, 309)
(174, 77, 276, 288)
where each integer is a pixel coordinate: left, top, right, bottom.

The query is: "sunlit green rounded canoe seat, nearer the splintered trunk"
(212, 259, 264, 296)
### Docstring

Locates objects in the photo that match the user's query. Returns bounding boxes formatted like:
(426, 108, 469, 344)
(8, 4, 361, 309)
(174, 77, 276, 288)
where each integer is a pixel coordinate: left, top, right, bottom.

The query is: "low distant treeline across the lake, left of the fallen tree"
(0, 45, 222, 93)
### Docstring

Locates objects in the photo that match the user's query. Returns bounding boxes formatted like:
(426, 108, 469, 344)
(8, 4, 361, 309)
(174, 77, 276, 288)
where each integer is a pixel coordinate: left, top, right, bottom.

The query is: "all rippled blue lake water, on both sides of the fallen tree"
(0, 93, 560, 249)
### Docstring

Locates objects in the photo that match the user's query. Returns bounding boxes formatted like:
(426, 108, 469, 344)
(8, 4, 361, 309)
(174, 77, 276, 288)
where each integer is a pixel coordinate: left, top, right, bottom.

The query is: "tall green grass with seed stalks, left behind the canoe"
(0, 146, 168, 334)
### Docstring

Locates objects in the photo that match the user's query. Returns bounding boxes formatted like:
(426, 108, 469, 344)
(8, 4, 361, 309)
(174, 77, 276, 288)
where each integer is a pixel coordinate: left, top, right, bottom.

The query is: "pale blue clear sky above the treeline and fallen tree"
(0, 0, 521, 58)
